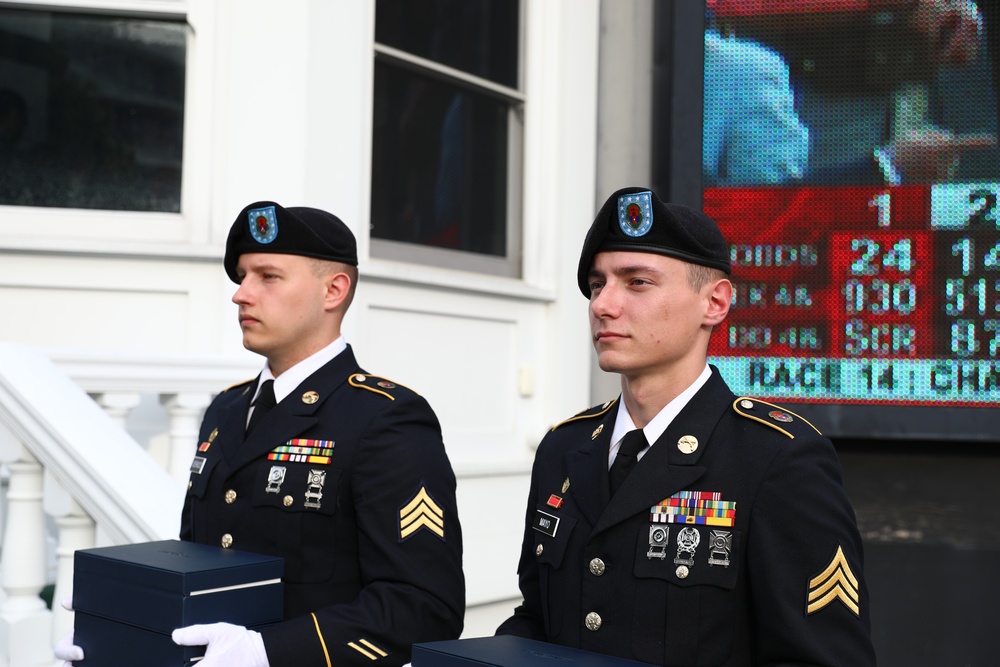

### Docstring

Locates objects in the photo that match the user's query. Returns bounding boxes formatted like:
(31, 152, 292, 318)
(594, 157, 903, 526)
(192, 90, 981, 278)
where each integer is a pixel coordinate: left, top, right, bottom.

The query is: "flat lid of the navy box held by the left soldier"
(73, 540, 285, 595)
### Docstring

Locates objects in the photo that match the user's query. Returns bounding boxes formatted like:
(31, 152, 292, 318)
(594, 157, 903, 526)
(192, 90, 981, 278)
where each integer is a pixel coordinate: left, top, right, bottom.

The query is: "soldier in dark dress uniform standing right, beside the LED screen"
(497, 188, 875, 667)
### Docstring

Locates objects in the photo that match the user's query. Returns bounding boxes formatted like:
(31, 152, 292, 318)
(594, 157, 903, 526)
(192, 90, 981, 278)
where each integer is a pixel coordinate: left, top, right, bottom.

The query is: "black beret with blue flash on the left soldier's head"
(223, 201, 358, 283)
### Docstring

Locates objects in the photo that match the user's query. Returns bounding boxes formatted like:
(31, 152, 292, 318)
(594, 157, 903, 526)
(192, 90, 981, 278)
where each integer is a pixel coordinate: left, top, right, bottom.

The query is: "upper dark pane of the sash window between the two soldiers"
(375, 0, 519, 88)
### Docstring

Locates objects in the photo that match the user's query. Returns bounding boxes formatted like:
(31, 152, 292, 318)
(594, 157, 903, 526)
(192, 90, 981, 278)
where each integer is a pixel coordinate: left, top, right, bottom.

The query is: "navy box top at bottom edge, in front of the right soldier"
(411, 635, 650, 667)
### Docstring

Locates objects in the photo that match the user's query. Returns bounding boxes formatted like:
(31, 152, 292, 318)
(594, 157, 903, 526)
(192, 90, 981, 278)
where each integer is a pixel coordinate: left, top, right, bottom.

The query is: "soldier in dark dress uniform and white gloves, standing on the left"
(174, 201, 465, 667)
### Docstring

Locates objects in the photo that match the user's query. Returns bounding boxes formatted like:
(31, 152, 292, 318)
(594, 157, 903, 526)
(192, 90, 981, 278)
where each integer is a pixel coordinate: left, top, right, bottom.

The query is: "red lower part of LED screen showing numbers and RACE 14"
(704, 184, 1000, 405)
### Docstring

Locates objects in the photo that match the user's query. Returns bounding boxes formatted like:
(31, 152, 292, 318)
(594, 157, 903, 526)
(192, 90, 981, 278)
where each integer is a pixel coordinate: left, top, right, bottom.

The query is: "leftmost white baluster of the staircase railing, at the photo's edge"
(0, 449, 53, 667)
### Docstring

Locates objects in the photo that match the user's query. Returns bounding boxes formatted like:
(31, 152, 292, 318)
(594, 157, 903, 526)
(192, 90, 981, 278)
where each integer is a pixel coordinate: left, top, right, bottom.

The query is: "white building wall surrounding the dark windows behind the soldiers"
(0, 0, 603, 632)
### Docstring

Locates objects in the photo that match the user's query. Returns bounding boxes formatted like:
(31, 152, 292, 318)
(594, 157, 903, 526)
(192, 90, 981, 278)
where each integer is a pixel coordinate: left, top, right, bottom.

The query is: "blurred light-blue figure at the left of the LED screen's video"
(702, 30, 809, 187)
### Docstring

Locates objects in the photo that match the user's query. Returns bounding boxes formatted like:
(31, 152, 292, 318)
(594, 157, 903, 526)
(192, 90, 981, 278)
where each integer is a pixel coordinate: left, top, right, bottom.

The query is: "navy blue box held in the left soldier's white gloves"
(73, 540, 284, 667)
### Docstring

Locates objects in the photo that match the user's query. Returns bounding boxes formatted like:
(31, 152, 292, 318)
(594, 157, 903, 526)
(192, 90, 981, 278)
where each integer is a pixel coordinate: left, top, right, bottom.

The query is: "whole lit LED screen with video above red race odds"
(701, 0, 1000, 439)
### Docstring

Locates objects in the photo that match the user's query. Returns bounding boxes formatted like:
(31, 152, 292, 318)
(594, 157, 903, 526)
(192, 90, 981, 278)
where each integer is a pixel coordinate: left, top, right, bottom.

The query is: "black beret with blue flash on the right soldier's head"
(576, 187, 732, 298)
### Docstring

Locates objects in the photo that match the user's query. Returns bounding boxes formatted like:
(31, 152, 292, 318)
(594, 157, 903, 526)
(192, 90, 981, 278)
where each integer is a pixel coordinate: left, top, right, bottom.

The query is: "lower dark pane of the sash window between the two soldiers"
(372, 63, 508, 257)
